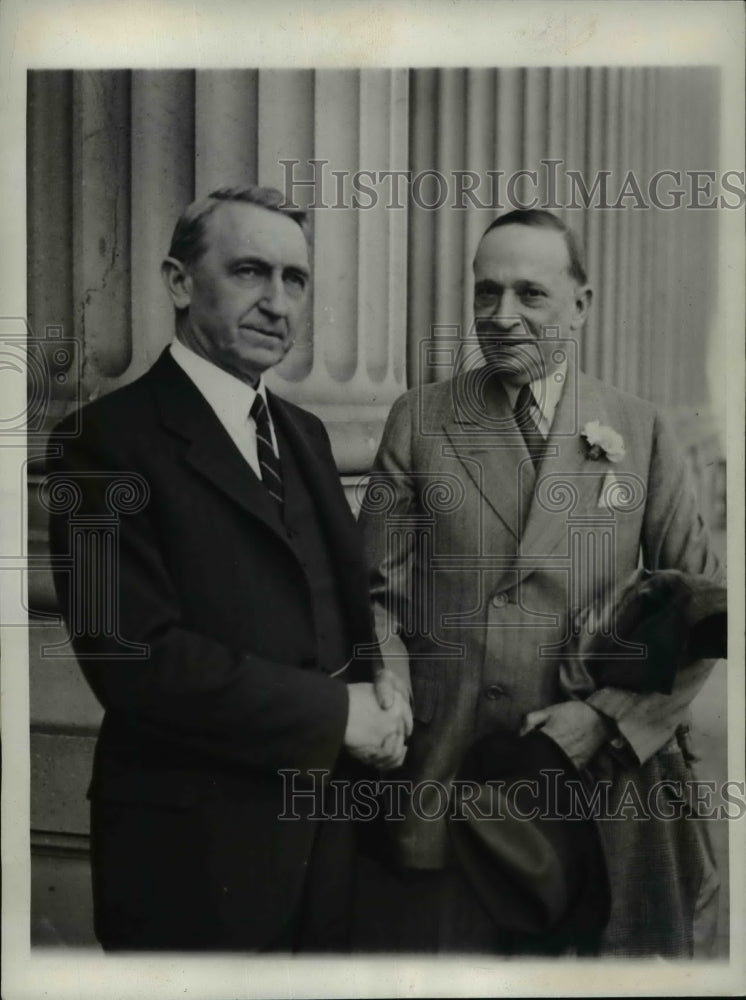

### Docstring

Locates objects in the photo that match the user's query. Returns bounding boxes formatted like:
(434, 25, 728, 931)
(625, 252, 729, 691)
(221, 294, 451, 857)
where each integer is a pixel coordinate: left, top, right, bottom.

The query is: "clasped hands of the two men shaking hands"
(344, 670, 412, 771)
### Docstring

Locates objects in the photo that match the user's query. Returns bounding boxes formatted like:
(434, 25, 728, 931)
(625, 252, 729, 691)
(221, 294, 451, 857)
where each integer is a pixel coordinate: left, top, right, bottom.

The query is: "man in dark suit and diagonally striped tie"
(46, 188, 411, 950)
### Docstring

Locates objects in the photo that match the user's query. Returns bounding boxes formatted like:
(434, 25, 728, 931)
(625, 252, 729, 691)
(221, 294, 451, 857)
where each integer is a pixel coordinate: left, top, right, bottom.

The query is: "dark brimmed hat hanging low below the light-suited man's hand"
(449, 730, 610, 954)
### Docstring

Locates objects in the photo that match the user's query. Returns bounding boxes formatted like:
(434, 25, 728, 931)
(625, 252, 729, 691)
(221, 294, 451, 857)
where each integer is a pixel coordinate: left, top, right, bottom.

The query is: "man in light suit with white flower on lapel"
(361, 211, 718, 955)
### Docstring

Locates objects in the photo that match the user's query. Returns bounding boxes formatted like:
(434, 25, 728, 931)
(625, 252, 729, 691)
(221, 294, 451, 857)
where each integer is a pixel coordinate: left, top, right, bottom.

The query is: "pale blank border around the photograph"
(0, 0, 746, 1000)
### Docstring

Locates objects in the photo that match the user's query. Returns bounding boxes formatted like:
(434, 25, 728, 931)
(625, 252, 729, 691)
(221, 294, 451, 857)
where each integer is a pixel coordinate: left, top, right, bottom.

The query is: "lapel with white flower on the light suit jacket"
(519, 367, 610, 577)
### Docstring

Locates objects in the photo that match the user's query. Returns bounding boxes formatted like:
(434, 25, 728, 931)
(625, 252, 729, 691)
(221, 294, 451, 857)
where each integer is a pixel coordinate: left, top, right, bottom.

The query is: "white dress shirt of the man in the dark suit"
(170, 340, 279, 479)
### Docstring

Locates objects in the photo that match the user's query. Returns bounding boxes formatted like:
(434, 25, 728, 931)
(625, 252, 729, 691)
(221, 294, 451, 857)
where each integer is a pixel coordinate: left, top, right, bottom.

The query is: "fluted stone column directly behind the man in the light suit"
(408, 67, 718, 405)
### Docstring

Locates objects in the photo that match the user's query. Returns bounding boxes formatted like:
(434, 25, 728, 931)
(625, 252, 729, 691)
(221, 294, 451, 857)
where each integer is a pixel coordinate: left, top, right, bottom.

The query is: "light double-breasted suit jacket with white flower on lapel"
(360, 369, 718, 952)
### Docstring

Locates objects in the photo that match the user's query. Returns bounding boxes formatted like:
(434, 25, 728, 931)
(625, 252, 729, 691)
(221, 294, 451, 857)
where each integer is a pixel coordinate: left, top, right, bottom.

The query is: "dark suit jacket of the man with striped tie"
(46, 352, 373, 949)
